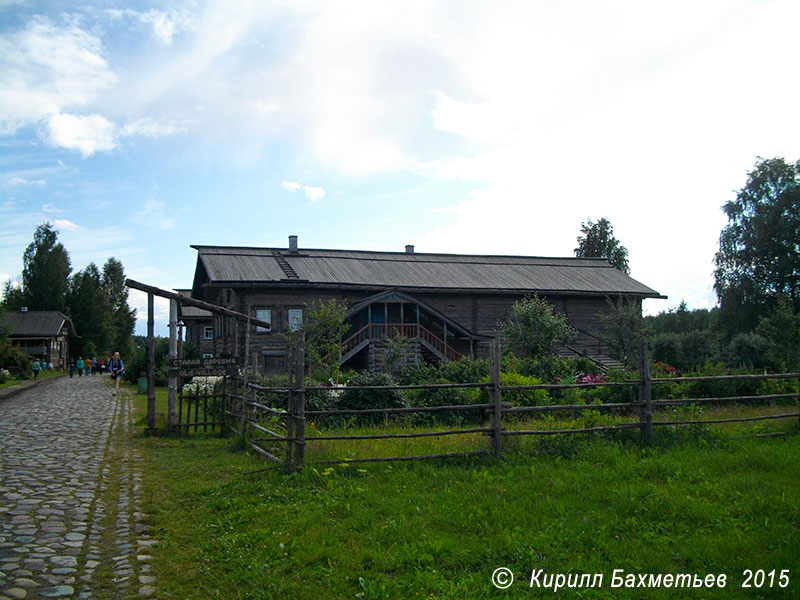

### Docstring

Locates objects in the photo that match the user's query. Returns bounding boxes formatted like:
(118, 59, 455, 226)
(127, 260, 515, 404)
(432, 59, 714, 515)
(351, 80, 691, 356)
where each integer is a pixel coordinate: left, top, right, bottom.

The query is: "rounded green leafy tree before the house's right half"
(500, 295, 576, 358)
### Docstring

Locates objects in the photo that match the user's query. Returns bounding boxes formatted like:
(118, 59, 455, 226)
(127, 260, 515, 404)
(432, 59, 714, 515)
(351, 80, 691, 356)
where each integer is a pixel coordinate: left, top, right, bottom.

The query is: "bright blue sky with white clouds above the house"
(0, 0, 800, 333)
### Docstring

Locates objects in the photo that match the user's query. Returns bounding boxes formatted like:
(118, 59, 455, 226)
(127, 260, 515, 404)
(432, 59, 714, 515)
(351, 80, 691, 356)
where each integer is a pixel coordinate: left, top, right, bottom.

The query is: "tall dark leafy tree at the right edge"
(714, 157, 800, 333)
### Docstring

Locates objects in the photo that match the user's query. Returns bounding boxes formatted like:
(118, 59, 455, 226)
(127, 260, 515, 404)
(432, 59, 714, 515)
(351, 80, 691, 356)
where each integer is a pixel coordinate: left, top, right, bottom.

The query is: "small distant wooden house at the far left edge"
(0, 309, 77, 368)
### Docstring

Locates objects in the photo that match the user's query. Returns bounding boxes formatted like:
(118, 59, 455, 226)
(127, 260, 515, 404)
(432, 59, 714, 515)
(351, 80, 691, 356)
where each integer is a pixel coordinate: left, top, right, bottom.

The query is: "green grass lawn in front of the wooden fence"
(135, 391, 800, 600)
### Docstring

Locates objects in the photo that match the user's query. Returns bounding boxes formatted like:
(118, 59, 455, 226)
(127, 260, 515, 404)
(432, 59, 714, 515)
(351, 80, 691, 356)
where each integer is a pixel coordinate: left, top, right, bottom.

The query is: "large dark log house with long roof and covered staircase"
(192, 236, 664, 373)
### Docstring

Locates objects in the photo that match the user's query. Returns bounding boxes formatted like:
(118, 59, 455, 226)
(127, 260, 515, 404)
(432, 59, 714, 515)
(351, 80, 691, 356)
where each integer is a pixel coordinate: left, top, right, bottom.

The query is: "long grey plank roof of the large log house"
(192, 246, 664, 298)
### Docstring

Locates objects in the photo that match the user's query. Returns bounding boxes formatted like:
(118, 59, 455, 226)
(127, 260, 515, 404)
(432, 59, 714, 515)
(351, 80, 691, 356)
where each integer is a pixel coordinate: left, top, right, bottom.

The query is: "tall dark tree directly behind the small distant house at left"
(22, 223, 72, 311)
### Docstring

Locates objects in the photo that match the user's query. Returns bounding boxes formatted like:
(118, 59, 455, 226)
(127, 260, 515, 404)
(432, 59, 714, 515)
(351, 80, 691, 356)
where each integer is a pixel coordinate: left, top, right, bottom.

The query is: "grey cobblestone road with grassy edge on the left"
(0, 375, 156, 600)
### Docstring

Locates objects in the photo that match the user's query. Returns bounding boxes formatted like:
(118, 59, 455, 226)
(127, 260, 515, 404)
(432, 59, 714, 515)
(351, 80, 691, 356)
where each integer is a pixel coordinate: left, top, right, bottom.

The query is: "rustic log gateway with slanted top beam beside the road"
(125, 279, 271, 429)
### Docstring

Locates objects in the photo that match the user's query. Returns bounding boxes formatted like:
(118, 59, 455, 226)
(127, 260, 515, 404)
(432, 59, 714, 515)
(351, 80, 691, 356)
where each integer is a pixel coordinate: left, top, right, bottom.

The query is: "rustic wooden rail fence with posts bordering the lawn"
(227, 335, 800, 469)
